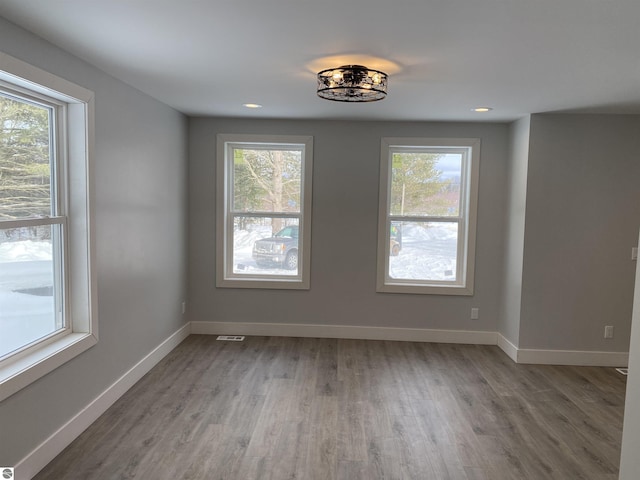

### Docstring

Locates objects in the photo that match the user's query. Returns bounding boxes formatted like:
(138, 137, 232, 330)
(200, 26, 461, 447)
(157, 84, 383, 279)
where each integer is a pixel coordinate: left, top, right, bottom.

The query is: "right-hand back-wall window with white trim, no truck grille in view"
(377, 138, 480, 295)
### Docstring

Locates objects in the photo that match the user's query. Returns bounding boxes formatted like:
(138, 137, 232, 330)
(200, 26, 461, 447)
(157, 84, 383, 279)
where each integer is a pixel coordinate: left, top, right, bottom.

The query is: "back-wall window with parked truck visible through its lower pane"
(217, 135, 313, 289)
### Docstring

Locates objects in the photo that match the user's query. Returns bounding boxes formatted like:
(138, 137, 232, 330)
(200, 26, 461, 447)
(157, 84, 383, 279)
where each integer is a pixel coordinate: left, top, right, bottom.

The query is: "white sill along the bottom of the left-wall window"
(0, 333, 98, 402)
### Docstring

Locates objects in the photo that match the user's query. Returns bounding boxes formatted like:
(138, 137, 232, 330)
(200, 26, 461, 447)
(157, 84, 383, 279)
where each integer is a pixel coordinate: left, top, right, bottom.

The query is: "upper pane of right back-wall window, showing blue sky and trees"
(391, 152, 462, 216)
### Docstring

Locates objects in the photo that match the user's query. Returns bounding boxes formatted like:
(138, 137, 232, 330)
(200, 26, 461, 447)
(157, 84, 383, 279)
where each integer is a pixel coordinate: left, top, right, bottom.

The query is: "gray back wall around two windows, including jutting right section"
(189, 115, 640, 352)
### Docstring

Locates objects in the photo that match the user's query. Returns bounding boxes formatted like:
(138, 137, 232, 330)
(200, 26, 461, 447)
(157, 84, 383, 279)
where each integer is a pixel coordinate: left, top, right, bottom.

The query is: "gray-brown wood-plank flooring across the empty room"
(36, 335, 625, 480)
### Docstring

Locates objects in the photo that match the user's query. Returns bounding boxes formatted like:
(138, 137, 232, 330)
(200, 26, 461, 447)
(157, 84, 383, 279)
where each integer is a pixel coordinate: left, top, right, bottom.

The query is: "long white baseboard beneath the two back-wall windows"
(191, 322, 497, 345)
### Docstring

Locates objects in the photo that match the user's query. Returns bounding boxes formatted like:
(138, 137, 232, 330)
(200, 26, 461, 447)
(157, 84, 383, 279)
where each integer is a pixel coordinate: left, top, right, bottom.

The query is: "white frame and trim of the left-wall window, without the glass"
(0, 52, 98, 401)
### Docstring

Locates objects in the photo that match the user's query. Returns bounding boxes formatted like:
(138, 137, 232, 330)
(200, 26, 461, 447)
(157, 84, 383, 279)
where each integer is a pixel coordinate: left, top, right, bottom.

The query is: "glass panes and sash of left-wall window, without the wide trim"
(0, 88, 69, 359)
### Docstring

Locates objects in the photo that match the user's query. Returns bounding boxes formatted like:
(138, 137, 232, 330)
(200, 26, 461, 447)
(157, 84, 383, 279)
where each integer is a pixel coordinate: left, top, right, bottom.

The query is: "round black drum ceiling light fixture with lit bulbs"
(318, 65, 387, 102)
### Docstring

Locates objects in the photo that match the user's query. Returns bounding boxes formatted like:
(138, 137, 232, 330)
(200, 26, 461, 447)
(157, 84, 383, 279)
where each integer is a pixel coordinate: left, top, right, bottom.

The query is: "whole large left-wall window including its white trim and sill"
(0, 53, 97, 400)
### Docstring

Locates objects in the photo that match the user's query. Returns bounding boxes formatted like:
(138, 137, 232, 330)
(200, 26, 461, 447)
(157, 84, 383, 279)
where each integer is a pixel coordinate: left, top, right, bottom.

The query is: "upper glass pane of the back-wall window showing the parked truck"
(233, 148, 302, 213)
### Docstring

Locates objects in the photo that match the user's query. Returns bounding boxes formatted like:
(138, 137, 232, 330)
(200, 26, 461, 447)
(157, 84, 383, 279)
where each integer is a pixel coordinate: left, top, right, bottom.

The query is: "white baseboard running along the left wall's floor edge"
(15, 323, 191, 479)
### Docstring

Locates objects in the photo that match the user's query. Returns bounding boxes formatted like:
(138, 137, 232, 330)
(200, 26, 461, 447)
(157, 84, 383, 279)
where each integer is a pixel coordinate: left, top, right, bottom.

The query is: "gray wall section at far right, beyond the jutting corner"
(519, 114, 640, 352)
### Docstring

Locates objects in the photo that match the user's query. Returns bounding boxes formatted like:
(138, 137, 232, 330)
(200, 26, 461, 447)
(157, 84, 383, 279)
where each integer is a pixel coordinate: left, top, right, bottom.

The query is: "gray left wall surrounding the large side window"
(0, 18, 187, 465)
